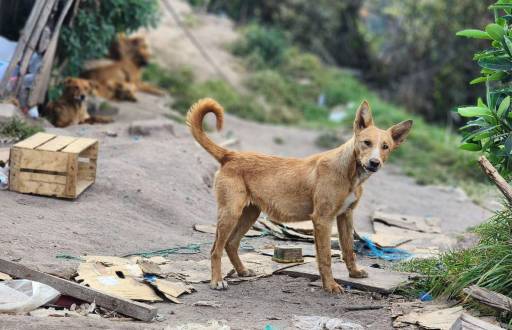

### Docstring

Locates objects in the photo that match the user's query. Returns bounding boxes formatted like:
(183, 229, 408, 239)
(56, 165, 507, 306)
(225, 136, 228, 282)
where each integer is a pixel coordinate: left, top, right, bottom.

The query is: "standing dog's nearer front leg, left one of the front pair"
(313, 218, 343, 293)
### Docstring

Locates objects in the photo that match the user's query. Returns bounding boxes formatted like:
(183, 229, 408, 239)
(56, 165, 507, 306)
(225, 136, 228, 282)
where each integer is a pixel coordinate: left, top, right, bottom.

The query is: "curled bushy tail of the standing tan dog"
(187, 98, 229, 164)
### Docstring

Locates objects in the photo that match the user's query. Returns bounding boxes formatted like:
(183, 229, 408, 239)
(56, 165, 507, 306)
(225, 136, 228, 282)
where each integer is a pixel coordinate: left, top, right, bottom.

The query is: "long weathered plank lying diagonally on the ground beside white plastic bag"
(0, 259, 158, 321)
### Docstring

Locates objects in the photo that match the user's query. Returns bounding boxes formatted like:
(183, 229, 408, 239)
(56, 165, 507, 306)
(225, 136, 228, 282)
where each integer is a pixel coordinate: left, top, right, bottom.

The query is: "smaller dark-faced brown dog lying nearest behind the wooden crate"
(43, 78, 112, 127)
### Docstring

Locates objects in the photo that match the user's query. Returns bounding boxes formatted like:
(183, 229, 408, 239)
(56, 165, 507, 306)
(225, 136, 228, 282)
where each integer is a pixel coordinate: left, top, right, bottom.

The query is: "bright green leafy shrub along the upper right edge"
(458, 0, 512, 180)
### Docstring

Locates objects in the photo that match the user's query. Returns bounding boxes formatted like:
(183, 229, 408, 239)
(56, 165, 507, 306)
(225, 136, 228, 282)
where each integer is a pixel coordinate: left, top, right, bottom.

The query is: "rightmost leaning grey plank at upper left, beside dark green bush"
(28, 0, 73, 106)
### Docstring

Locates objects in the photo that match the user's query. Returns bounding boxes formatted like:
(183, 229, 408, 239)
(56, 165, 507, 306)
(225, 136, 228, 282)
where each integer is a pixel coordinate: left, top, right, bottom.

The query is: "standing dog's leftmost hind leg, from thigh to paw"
(210, 177, 247, 290)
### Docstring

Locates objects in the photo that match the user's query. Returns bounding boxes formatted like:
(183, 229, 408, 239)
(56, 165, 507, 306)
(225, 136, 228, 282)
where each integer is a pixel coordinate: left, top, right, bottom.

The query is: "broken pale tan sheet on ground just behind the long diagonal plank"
(75, 262, 162, 302)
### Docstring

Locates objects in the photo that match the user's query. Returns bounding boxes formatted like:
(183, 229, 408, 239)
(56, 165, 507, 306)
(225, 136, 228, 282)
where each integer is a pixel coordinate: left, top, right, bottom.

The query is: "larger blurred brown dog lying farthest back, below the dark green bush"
(82, 34, 164, 101)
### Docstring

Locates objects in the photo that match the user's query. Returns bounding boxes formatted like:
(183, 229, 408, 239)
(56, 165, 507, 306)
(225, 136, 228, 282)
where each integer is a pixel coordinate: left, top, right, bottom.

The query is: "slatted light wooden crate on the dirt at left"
(9, 133, 98, 198)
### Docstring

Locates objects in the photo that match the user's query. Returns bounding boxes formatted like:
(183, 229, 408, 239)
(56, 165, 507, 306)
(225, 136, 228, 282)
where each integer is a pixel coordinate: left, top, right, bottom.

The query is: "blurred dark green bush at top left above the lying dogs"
(58, 0, 158, 76)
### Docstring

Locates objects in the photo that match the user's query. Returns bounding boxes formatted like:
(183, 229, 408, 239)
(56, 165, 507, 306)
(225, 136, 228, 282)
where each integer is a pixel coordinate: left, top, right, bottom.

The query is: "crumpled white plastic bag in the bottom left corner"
(0, 280, 60, 314)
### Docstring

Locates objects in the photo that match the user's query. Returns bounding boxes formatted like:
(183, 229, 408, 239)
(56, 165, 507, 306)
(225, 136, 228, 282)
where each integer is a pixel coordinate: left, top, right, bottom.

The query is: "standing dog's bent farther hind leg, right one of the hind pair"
(226, 204, 261, 277)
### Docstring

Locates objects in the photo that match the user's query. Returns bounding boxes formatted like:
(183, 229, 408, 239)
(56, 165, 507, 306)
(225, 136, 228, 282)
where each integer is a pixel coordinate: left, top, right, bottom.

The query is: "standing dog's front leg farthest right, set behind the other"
(336, 209, 368, 278)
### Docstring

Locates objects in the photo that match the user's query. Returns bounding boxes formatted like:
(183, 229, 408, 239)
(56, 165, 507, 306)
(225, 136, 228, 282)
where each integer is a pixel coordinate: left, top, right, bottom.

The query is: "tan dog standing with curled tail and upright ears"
(187, 99, 412, 293)
